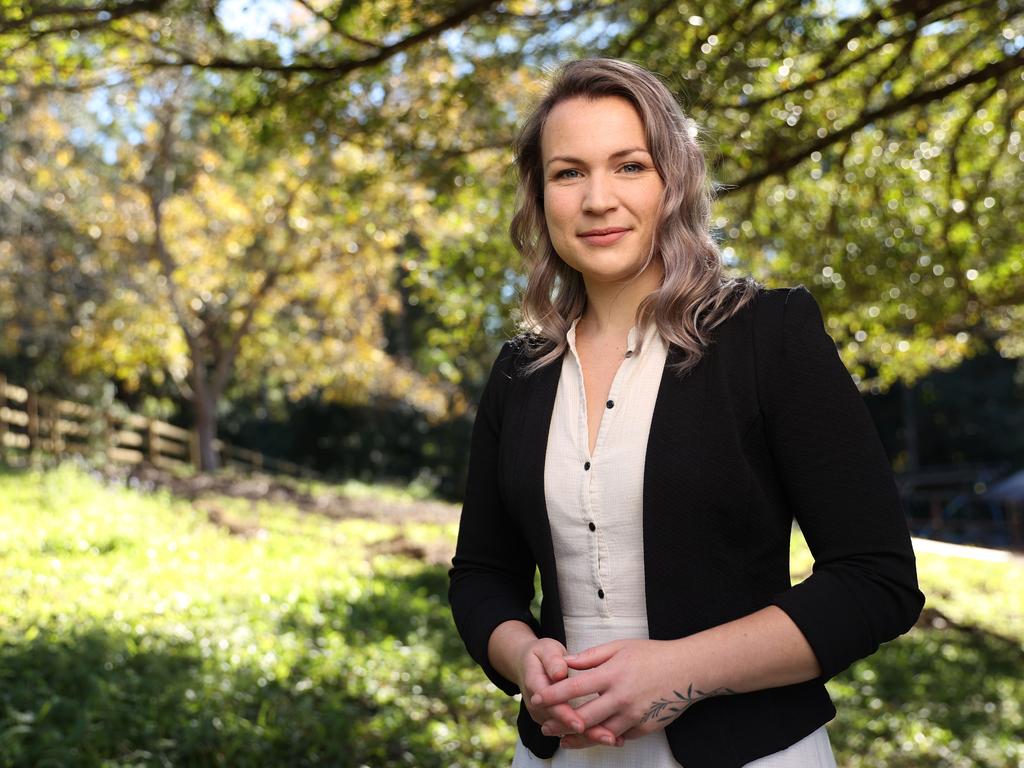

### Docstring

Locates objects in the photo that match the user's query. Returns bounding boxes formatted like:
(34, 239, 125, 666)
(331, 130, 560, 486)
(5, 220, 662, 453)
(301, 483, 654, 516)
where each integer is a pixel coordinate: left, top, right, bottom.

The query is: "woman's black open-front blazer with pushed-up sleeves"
(449, 286, 924, 768)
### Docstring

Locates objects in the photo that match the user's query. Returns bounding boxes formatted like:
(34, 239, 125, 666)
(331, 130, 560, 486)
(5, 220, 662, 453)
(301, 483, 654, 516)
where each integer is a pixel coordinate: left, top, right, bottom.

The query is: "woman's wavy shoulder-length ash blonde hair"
(510, 58, 763, 376)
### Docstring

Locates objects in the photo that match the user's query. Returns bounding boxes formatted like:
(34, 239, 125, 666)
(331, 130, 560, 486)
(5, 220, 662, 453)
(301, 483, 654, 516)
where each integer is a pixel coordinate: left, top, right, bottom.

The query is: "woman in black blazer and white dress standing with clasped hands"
(450, 58, 924, 768)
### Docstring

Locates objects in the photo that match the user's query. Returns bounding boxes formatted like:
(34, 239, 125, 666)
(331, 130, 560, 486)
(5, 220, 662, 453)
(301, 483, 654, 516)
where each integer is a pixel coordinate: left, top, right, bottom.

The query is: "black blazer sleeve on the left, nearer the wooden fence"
(449, 342, 541, 695)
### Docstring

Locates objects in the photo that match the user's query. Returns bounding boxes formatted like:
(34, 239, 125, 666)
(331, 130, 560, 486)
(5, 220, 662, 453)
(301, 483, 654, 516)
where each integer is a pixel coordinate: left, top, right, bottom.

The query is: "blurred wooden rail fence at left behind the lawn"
(0, 374, 312, 476)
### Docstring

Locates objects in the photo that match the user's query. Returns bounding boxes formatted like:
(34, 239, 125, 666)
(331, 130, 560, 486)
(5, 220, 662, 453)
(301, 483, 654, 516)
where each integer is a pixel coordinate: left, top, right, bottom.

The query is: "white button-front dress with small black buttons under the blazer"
(512, 317, 836, 768)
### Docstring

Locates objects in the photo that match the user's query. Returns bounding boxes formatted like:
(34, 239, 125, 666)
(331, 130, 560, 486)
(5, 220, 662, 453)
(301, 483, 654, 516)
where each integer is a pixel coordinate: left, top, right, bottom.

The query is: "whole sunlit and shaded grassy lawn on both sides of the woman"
(0, 467, 1024, 768)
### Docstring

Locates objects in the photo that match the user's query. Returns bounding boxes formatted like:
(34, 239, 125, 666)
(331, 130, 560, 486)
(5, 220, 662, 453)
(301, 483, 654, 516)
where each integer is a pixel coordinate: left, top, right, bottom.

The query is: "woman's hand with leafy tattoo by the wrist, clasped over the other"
(532, 639, 732, 748)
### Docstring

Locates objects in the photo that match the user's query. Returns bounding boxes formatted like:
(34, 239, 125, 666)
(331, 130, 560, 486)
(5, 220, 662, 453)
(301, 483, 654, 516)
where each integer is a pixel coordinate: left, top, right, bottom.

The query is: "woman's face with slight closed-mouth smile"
(541, 96, 665, 283)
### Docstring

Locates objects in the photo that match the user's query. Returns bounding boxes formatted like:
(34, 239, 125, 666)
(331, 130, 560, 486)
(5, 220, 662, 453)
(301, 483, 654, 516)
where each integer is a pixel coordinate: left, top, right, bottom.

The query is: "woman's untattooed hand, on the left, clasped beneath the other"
(516, 638, 623, 749)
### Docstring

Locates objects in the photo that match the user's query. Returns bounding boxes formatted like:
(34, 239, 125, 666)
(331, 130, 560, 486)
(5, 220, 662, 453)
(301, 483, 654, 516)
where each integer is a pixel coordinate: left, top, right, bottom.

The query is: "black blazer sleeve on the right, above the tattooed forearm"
(759, 286, 925, 682)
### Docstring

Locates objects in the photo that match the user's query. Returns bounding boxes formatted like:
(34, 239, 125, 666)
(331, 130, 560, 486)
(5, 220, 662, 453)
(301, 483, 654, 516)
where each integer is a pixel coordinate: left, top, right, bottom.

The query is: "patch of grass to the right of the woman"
(793, 534, 1024, 768)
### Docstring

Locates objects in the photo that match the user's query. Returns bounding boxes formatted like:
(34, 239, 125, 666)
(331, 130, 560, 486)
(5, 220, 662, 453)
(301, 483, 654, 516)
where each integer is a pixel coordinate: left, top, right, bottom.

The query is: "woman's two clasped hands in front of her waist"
(520, 638, 689, 749)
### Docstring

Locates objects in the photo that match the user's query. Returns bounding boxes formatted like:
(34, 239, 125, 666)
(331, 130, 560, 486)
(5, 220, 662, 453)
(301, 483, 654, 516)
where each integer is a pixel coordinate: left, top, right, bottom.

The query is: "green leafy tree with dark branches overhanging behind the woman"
(0, 0, 1024, 475)
